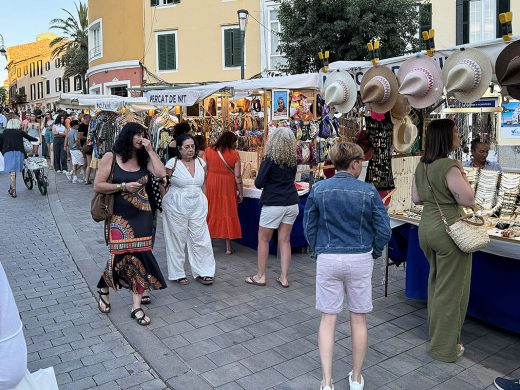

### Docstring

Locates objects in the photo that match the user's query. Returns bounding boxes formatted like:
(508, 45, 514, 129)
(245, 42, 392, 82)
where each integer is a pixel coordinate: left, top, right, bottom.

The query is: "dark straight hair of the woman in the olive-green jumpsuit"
(421, 119, 455, 164)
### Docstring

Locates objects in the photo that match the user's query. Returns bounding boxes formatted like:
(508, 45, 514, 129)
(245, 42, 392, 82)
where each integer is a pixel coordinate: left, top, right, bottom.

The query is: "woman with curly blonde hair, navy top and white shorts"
(246, 127, 300, 287)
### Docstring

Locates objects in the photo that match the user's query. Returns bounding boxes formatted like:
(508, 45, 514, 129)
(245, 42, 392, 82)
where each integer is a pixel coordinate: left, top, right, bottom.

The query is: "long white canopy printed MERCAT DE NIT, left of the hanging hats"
(145, 73, 319, 107)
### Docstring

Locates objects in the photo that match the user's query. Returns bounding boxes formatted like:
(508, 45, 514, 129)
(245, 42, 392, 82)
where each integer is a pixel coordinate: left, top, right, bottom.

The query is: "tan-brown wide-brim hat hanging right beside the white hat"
(360, 65, 398, 114)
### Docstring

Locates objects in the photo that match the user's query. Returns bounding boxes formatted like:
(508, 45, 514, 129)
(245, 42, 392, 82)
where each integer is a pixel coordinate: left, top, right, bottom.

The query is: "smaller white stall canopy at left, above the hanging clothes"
(56, 93, 155, 112)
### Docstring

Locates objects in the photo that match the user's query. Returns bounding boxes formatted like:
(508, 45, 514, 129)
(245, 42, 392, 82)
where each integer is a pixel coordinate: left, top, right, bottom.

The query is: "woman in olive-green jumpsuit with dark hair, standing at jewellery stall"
(412, 119, 475, 362)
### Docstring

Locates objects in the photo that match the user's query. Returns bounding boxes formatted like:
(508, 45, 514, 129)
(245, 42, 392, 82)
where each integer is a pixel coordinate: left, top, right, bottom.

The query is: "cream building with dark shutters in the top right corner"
(429, 0, 520, 49)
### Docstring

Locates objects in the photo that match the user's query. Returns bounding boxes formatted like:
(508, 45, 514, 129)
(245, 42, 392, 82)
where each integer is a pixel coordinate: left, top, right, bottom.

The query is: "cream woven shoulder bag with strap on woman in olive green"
(424, 164, 490, 253)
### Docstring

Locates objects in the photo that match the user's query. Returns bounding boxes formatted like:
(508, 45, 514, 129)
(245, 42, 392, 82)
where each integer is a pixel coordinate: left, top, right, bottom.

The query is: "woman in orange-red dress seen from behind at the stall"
(206, 131, 244, 255)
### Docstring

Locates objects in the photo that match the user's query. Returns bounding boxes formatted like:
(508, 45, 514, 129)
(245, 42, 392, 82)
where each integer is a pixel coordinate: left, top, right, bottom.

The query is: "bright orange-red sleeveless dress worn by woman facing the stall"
(206, 148, 242, 240)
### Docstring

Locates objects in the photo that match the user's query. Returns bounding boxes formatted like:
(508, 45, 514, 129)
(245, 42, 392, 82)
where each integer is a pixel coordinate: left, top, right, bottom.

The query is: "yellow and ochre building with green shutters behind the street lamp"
(87, 0, 285, 96)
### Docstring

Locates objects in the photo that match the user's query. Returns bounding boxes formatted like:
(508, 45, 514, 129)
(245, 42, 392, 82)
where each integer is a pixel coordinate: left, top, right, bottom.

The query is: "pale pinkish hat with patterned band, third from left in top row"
(397, 55, 444, 108)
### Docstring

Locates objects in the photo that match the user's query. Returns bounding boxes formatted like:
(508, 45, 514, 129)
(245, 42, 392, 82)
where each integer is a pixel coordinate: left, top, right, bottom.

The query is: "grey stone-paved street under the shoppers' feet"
(0, 172, 520, 390)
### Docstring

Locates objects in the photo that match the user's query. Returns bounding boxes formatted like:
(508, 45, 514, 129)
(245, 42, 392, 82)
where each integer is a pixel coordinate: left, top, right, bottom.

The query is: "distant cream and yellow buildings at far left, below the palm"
(7, 33, 83, 111)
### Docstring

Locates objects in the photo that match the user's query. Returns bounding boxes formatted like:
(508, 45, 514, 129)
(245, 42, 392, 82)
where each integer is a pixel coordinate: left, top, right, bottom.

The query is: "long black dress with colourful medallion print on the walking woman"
(97, 163, 166, 294)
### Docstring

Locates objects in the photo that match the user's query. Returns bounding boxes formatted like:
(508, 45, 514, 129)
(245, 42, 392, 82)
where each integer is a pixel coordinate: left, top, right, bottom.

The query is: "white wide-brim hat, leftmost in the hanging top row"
(323, 70, 357, 113)
